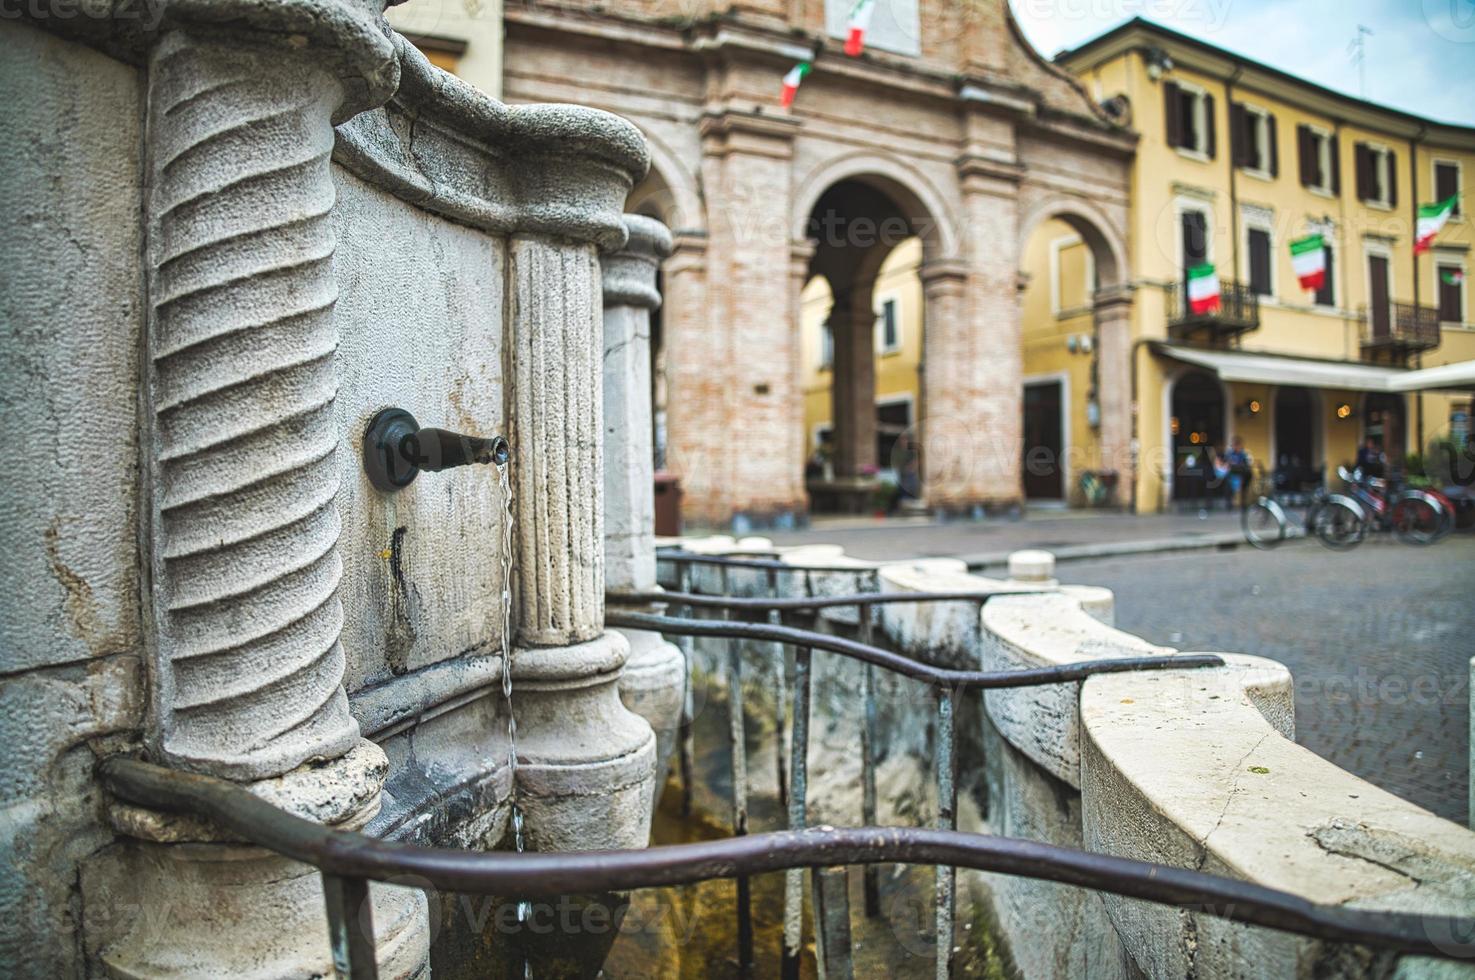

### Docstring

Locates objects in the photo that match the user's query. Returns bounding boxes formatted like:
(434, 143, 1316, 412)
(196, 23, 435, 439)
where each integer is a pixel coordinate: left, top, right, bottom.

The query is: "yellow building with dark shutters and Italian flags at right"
(1038, 19, 1475, 511)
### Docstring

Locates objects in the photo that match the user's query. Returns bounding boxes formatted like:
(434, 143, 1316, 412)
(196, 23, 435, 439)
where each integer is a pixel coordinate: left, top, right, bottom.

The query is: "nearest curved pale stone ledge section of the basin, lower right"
(1080, 655, 1475, 976)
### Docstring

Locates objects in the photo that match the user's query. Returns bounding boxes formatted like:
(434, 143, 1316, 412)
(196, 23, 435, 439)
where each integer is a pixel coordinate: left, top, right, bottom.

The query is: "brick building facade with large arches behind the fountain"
(504, 0, 1134, 527)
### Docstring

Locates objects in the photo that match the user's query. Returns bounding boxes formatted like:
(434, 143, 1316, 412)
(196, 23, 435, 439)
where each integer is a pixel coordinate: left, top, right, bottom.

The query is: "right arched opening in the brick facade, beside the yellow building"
(1019, 210, 1133, 505)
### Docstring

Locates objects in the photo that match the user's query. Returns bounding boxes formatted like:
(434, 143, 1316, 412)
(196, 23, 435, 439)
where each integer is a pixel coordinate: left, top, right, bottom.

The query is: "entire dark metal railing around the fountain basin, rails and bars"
(100, 552, 1475, 980)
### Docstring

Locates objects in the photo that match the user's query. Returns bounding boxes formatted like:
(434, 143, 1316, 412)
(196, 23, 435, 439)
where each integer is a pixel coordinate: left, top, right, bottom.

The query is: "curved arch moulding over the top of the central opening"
(792, 151, 962, 263)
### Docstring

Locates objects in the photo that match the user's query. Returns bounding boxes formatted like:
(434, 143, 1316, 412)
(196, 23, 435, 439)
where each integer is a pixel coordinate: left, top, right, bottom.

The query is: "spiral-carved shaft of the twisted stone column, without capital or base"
(148, 31, 358, 779)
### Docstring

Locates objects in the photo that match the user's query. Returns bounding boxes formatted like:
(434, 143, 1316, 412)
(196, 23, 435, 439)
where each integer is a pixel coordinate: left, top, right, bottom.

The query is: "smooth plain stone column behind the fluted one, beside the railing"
(600, 214, 686, 806)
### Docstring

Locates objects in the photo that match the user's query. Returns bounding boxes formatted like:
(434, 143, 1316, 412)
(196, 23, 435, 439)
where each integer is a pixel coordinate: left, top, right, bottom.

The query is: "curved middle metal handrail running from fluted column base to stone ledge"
(605, 608, 1224, 691)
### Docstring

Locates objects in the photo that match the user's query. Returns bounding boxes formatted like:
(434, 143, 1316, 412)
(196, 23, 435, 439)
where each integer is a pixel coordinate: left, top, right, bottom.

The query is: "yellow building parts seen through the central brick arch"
(799, 238, 922, 492)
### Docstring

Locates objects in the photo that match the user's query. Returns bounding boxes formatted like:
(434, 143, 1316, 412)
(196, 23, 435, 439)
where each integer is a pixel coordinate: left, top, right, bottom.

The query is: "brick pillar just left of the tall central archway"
(693, 109, 804, 527)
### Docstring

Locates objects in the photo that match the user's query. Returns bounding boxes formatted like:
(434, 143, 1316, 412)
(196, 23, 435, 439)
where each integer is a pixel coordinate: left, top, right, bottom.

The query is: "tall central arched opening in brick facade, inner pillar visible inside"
(799, 177, 934, 514)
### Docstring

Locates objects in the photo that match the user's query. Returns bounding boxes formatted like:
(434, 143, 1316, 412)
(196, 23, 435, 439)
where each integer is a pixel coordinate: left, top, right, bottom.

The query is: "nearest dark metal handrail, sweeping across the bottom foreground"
(99, 757, 1475, 962)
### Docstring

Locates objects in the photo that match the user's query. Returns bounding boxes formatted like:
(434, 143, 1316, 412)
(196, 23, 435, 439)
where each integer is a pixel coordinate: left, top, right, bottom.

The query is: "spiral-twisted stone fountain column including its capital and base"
(83, 17, 429, 977)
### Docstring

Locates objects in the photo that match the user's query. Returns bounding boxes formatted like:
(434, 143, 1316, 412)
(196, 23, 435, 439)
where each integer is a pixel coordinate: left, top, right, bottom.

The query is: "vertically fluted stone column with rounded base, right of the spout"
(509, 235, 656, 850)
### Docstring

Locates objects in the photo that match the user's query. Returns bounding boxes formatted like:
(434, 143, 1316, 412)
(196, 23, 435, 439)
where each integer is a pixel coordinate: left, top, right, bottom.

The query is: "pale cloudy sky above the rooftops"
(1009, 0, 1475, 125)
